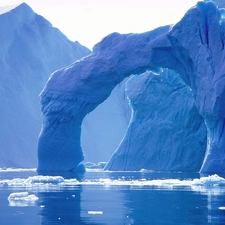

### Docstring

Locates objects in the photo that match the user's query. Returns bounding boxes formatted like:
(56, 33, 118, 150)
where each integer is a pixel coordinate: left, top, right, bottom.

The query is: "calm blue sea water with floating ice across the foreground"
(0, 169, 225, 225)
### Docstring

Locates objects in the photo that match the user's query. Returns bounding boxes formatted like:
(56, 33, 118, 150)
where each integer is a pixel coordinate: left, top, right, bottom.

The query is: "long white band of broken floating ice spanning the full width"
(0, 174, 225, 191)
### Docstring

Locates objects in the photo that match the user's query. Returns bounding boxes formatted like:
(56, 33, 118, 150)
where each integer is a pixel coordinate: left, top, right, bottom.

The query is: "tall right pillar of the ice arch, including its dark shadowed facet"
(151, 2, 225, 173)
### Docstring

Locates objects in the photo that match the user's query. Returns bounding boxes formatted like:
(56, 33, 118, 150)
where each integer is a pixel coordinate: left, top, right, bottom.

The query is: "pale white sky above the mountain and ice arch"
(0, 0, 200, 49)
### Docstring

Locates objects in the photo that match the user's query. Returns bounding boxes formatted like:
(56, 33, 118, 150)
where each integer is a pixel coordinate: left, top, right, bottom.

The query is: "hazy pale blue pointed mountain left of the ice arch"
(0, 3, 91, 167)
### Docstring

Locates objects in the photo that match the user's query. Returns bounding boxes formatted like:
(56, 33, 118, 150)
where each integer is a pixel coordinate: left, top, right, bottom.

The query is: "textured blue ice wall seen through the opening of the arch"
(105, 69, 206, 171)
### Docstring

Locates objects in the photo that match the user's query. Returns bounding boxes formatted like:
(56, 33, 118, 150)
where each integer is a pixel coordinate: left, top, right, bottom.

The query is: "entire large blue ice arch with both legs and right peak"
(38, 2, 225, 172)
